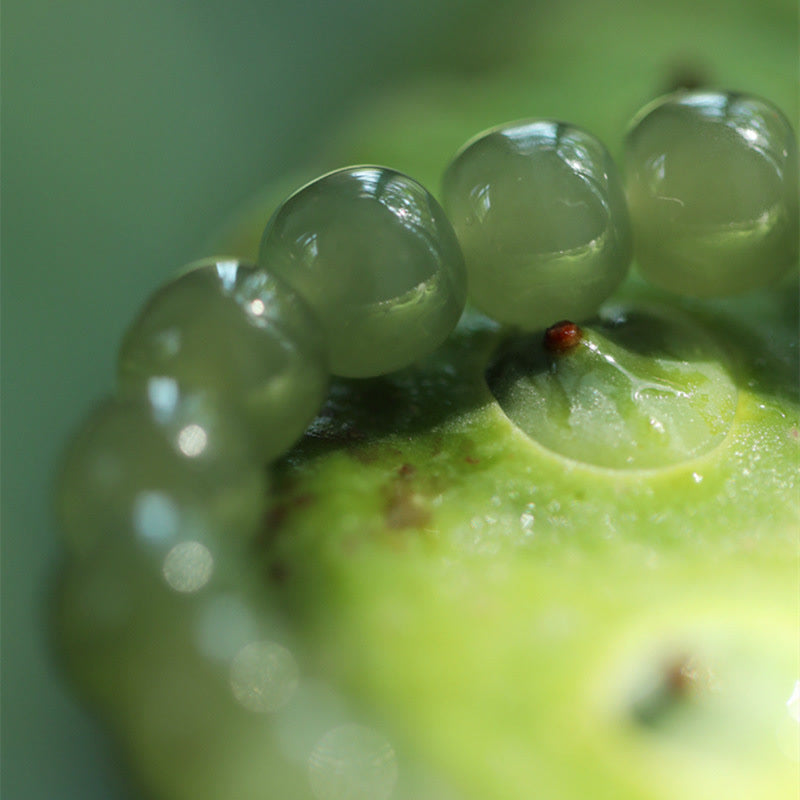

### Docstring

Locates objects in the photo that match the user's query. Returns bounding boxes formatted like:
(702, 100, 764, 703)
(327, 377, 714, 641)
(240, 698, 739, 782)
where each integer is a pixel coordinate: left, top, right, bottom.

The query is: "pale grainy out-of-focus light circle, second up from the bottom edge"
(230, 642, 299, 713)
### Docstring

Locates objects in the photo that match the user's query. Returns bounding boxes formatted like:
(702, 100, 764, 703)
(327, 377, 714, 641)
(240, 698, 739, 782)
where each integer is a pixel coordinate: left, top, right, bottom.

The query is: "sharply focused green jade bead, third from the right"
(259, 167, 466, 377)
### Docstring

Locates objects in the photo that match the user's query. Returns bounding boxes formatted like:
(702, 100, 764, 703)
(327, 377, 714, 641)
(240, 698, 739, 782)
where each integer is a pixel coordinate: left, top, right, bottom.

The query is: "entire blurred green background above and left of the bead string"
(0, 0, 798, 800)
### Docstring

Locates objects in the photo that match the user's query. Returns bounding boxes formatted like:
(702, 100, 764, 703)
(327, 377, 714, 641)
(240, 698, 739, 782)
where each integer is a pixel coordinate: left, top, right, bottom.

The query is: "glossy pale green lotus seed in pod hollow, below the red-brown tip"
(489, 313, 737, 469)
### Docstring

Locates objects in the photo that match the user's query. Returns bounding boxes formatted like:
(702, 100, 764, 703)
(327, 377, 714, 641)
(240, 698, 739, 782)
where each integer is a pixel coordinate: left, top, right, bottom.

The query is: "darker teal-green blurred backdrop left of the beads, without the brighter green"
(2, 0, 506, 800)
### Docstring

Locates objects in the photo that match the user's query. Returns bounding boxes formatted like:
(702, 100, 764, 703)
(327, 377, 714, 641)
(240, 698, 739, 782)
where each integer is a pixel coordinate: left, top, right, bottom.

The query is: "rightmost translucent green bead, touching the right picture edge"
(625, 92, 800, 297)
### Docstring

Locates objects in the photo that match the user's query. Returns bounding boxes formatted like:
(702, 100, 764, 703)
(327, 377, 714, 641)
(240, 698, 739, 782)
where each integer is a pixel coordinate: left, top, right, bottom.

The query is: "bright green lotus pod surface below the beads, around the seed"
(255, 282, 798, 798)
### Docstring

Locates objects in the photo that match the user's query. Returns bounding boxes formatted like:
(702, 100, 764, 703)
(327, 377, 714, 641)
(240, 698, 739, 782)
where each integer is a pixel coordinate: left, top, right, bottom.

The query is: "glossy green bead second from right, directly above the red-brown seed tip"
(443, 120, 631, 330)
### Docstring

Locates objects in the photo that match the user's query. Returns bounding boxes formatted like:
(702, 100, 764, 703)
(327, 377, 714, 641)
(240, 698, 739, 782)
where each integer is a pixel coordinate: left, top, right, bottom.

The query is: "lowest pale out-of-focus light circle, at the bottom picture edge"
(308, 724, 397, 800)
